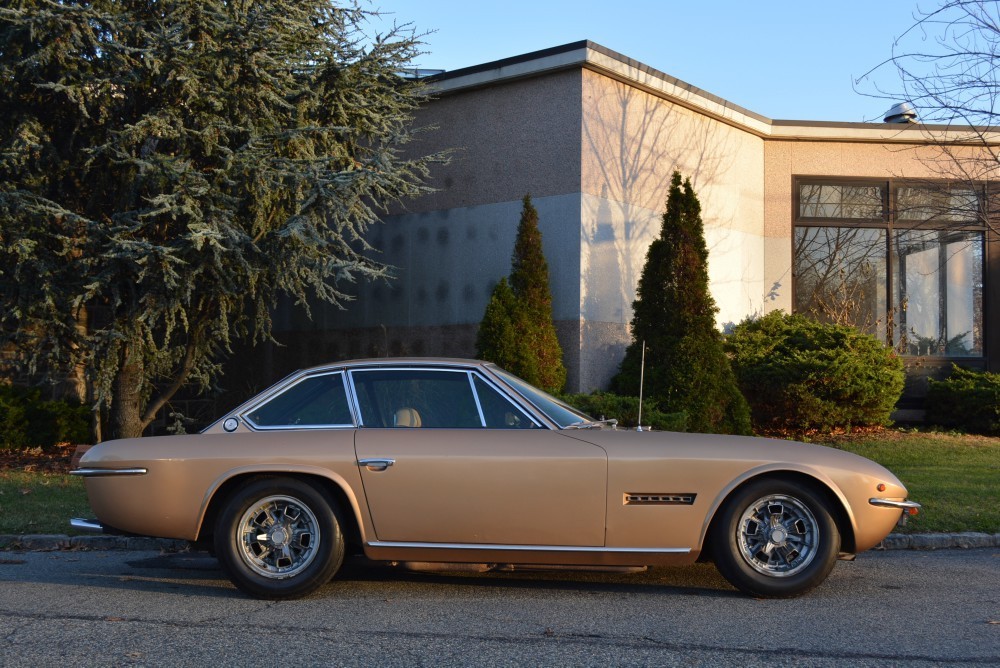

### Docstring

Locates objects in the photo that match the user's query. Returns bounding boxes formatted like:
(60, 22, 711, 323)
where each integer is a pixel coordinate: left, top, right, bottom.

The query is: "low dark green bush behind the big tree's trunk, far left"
(0, 385, 90, 449)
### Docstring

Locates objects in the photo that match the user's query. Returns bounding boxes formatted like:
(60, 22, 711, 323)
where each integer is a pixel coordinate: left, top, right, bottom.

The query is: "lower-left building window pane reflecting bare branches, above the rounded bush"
(792, 227, 886, 340)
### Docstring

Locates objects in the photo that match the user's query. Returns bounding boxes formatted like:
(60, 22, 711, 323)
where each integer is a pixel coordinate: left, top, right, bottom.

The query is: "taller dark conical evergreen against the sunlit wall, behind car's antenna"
(612, 172, 750, 434)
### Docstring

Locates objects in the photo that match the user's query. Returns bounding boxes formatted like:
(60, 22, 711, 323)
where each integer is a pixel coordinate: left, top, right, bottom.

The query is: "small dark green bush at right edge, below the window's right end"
(925, 365, 1000, 436)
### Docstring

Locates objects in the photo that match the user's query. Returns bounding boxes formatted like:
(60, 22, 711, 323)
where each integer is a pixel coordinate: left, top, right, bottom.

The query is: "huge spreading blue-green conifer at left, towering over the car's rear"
(0, 0, 438, 437)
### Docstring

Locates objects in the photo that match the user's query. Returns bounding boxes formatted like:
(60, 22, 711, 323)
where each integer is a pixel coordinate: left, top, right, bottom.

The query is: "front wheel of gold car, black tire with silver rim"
(710, 479, 840, 598)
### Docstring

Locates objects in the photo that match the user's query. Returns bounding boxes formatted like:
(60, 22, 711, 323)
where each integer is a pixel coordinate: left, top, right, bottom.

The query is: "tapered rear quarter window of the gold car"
(246, 373, 354, 427)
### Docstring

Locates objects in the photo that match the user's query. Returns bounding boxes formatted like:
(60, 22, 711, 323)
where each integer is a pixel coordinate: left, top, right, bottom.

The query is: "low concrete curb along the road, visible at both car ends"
(0, 531, 1000, 552)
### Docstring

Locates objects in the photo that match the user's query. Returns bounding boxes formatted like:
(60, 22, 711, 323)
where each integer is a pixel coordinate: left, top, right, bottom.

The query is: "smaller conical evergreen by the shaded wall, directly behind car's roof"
(476, 195, 566, 392)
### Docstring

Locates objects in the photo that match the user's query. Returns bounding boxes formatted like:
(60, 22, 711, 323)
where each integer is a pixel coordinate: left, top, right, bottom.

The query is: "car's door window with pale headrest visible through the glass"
(351, 369, 483, 429)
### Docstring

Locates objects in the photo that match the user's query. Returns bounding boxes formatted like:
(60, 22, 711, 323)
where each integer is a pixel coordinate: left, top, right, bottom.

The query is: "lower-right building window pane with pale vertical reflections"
(893, 230, 983, 357)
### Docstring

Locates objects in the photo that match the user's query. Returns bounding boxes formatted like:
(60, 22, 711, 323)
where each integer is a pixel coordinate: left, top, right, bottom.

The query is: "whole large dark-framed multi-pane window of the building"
(793, 179, 986, 357)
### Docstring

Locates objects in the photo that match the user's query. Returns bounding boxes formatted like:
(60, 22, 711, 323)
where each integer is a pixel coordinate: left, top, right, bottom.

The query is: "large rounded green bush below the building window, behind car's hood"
(726, 311, 905, 431)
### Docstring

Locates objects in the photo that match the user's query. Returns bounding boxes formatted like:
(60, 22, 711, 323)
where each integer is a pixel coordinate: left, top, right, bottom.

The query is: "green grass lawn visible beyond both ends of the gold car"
(0, 430, 1000, 534)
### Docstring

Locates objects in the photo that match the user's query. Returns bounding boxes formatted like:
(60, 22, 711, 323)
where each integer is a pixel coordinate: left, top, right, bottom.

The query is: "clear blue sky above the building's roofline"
(373, 0, 937, 121)
